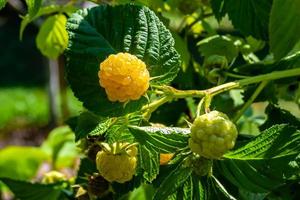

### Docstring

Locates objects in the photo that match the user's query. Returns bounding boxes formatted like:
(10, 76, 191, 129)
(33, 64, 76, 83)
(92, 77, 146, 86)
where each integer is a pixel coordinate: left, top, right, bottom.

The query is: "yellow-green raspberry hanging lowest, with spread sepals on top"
(96, 143, 137, 183)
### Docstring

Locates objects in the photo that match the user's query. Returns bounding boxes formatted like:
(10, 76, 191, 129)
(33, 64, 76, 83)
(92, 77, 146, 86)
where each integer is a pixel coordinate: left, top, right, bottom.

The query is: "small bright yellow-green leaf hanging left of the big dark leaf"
(36, 14, 68, 59)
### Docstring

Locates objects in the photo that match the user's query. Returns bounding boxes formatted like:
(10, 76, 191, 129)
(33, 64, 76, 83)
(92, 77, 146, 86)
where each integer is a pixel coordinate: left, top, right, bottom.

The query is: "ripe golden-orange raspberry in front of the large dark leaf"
(98, 53, 150, 102)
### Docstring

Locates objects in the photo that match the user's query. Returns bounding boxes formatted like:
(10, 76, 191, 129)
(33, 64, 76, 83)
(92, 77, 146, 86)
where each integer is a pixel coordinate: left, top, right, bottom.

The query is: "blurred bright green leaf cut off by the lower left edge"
(0, 146, 50, 180)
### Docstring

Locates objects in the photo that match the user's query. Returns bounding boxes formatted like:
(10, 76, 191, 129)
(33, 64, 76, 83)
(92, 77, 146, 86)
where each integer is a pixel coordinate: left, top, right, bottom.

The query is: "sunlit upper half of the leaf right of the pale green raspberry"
(224, 124, 300, 160)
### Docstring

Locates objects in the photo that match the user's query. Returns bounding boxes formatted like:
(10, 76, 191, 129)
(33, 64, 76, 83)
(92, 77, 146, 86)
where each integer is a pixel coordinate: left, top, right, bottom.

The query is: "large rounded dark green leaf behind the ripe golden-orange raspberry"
(66, 5, 180, 116)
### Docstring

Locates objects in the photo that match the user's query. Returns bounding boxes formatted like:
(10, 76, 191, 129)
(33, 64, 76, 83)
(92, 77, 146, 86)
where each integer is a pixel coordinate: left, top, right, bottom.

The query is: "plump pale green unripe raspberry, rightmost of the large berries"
(189, 111, 238, 159)
